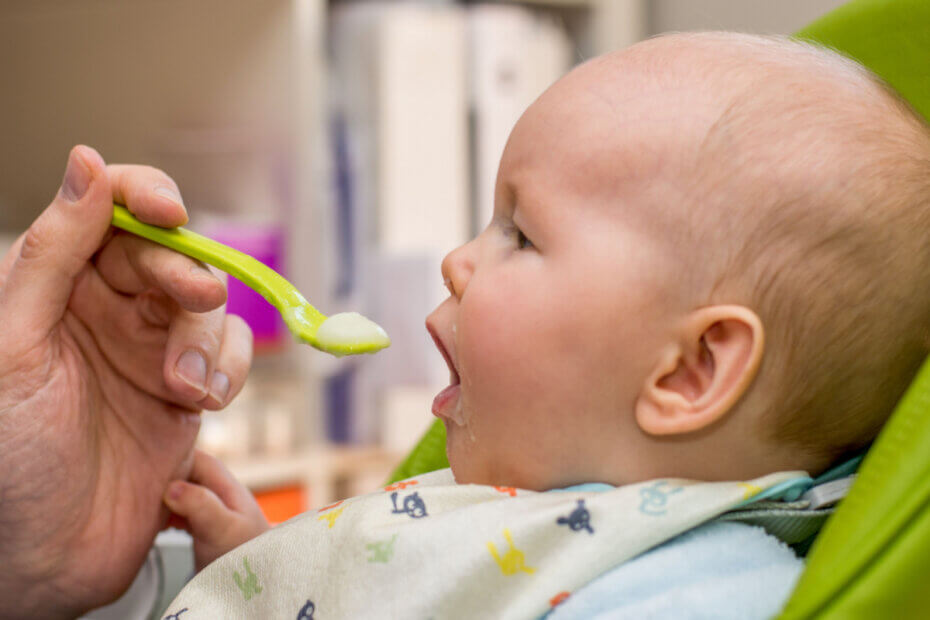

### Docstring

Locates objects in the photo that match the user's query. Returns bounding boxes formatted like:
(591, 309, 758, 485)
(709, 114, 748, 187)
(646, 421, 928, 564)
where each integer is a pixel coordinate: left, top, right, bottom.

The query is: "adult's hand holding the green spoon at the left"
(0, 146, 252, 618)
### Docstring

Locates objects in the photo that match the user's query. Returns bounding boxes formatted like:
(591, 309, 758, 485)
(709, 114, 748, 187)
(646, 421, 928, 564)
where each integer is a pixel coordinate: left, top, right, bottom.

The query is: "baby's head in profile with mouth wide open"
(427, 33, 930, 489)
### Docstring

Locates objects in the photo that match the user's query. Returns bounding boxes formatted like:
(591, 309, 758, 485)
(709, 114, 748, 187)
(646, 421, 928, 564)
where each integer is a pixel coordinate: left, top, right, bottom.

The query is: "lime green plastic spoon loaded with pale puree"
(112, 204, 391, 356)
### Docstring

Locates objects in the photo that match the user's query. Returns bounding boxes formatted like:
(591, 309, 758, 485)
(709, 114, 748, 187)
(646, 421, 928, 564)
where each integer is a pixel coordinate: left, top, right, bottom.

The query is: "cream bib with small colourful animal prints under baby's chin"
(166, 469, 806, 620)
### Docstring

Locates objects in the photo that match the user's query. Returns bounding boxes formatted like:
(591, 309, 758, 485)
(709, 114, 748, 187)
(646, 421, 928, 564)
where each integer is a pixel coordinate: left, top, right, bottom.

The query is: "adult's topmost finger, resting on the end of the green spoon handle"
(107, 164, 187, 228)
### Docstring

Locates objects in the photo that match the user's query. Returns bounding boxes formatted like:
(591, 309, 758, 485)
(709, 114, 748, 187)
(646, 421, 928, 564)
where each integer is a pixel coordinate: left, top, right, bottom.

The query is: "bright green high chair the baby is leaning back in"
(391, 0, 930, 620)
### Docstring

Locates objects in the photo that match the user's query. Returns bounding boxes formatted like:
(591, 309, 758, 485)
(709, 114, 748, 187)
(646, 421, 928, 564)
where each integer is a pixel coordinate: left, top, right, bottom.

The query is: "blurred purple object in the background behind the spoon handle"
(204, 220, 287, 350)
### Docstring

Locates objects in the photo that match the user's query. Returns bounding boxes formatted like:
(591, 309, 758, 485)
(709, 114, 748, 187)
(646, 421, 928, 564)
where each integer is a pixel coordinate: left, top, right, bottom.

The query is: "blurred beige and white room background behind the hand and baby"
(0, 0, 842, 521)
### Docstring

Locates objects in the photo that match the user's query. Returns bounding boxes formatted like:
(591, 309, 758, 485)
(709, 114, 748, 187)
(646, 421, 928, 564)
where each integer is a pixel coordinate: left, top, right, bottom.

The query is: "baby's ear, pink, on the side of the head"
(634, 306, 765, 435)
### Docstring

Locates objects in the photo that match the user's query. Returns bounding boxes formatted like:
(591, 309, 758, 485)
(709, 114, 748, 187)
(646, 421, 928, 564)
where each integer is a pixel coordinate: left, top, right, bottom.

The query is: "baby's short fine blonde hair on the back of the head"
(679, 33, 930, 466)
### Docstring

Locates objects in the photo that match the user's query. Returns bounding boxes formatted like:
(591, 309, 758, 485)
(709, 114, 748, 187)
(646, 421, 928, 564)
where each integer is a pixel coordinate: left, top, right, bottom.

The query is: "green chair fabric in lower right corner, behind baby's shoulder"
(781, 360, 930, 620)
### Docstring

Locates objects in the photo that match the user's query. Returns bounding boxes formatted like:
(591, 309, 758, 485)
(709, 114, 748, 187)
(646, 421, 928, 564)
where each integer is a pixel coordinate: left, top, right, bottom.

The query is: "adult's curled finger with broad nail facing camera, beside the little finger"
(164, 306, 226, 403)
